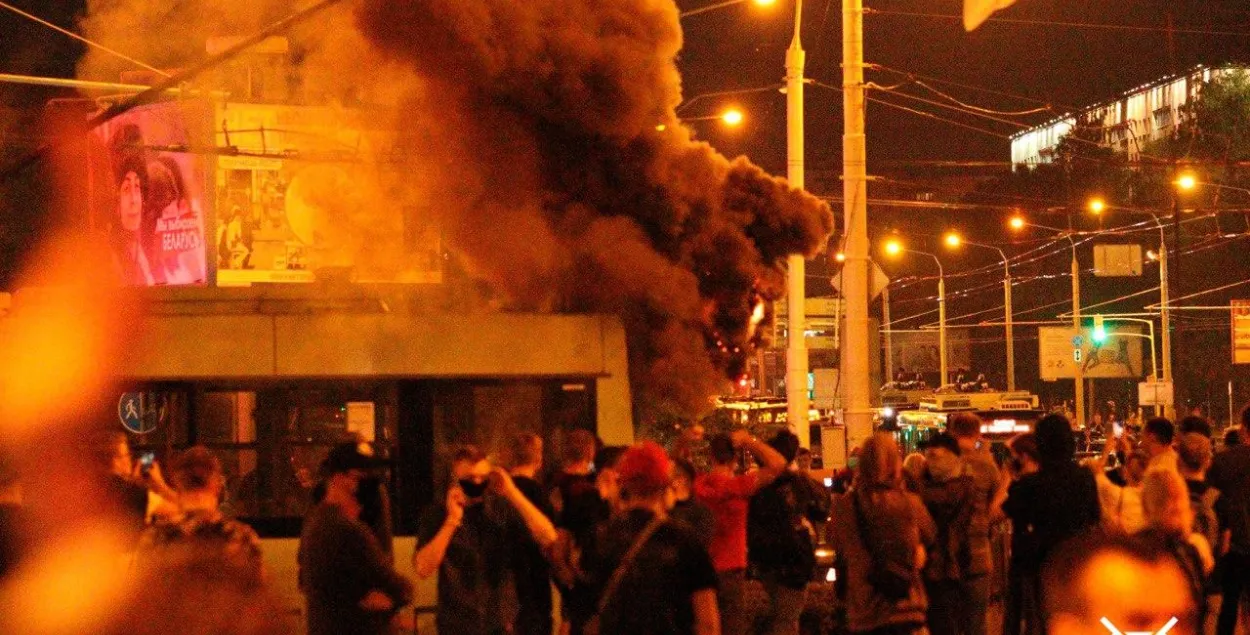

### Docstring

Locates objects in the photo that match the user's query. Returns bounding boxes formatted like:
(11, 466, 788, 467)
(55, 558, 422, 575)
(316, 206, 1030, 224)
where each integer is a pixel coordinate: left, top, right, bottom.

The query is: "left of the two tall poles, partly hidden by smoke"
(785, 0, 811, 448)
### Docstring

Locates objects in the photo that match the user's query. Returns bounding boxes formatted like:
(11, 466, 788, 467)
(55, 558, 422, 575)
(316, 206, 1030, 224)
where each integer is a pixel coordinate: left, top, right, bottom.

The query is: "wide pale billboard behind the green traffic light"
(1038, 321, 1153, 381)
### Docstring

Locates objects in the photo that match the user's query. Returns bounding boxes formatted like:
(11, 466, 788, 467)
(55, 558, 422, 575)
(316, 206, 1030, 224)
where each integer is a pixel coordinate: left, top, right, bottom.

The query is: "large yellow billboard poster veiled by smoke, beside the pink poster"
(214, 104, 444, 286)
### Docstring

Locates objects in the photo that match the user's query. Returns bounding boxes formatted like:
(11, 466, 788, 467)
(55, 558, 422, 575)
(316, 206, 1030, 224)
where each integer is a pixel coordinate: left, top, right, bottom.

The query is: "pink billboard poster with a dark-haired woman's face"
(90, 103, 208, 286)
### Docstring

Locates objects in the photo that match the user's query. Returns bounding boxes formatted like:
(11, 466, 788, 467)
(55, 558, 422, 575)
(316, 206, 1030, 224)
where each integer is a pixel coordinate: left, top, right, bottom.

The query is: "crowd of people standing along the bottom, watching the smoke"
(0, 409, 1250, 635)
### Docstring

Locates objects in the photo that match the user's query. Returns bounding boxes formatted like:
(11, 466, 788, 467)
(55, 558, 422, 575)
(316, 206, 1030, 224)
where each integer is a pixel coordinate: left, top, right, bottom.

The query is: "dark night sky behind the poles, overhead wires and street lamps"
(7, 0, 1250, 412)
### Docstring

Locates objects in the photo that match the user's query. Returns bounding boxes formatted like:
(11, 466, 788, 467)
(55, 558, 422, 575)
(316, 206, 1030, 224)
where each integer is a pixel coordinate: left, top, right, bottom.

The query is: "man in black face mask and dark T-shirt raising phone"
(413, 446, 556, 634)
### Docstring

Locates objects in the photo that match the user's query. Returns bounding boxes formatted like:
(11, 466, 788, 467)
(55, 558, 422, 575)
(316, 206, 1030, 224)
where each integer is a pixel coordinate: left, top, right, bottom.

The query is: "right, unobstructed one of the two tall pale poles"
(840, 0, 873, 448)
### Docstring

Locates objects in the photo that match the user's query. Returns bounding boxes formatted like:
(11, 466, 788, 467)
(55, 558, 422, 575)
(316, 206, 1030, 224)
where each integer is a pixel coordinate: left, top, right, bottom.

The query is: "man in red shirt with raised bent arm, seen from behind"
(695, 430, 786, 635)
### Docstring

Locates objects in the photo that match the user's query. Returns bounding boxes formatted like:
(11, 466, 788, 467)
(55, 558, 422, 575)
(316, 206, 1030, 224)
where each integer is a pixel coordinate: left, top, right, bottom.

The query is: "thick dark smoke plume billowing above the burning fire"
(359, 0, 833, 415)
